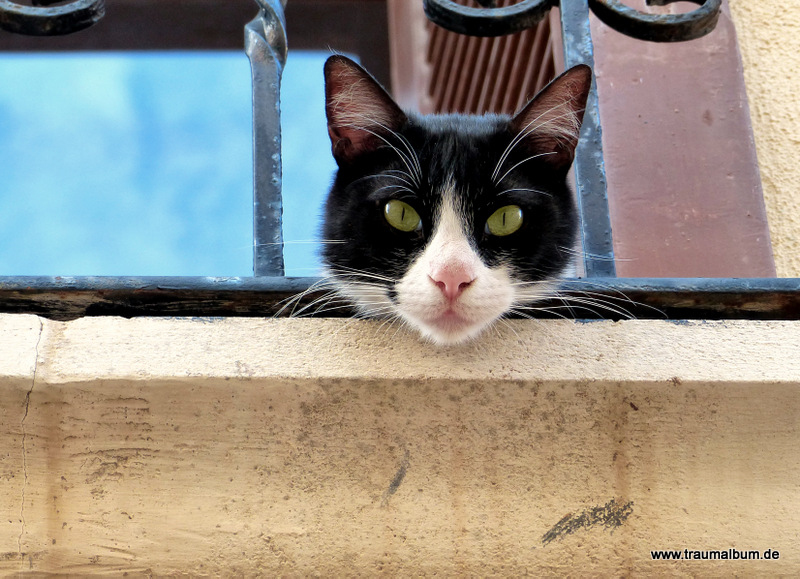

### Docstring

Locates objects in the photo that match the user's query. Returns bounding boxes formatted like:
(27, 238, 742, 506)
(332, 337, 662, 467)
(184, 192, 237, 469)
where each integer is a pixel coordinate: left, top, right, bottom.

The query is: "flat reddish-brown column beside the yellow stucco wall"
(592, 0, 775, 277)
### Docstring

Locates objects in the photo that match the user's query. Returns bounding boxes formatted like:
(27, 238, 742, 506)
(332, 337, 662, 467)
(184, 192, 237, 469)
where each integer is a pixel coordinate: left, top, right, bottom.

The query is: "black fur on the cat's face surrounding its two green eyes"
(323, 115, 576, 281)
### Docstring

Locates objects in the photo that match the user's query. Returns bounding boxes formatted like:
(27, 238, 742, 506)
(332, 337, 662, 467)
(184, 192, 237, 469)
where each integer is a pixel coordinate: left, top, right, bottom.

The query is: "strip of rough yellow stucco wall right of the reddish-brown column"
(730, 0, 800, 277)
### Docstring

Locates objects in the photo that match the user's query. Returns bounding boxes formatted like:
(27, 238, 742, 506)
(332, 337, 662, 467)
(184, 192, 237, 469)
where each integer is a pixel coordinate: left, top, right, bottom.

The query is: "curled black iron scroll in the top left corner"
(0, 0, 106, 36)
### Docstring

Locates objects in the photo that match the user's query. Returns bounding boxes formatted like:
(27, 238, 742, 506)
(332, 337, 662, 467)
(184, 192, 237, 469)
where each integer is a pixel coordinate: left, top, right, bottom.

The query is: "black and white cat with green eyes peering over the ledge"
(323, 55, 591, 344)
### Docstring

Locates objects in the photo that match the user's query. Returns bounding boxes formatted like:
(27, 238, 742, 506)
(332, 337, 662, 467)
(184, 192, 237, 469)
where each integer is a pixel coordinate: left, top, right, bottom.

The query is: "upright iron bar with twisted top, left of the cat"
(244, 0, 288, 277)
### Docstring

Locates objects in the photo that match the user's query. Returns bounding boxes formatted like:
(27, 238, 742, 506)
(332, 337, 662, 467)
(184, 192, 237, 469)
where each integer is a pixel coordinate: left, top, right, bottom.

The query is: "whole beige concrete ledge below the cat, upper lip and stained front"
(0, 315, 800, 576)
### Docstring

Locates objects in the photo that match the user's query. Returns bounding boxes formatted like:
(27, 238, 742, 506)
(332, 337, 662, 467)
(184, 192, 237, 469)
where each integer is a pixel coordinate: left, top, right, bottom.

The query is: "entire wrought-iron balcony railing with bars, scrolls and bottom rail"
(0, 0, 800, 319)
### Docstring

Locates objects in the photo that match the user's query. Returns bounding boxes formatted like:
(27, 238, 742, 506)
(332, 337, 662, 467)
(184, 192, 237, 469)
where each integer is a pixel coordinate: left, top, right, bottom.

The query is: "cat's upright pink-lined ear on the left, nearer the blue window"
(325, 54, 407, 166)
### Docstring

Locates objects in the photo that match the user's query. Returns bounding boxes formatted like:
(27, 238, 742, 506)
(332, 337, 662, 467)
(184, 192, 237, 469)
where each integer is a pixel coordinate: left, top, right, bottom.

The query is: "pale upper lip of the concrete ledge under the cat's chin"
(23, 316, 800, 384)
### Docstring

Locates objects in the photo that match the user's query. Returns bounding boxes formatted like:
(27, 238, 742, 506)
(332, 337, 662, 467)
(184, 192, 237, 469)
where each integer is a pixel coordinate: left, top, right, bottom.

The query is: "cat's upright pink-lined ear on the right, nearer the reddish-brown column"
(511, 64, 592, 170)
